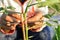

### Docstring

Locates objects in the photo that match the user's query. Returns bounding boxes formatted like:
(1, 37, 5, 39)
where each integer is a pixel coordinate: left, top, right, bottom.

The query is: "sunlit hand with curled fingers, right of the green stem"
(28, 12, 44, 32)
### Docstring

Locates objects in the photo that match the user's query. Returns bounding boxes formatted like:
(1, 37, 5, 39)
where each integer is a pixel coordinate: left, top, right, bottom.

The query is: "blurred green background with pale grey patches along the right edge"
(36, 0, 60, 40)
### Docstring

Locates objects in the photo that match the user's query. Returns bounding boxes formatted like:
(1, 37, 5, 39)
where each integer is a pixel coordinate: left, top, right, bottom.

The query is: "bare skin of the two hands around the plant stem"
(0, 12, 43, 33)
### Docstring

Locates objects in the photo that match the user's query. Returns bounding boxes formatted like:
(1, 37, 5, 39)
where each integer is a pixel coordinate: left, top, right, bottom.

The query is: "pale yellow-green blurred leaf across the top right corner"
(36, 0, 60, 7)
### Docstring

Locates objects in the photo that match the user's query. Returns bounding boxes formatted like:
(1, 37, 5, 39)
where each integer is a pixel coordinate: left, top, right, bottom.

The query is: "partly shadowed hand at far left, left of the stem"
(0, 12, 20, 34)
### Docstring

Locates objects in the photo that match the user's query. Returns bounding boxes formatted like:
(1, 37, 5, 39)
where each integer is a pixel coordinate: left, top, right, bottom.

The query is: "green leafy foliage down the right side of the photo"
(37, 0, 60, 40)
